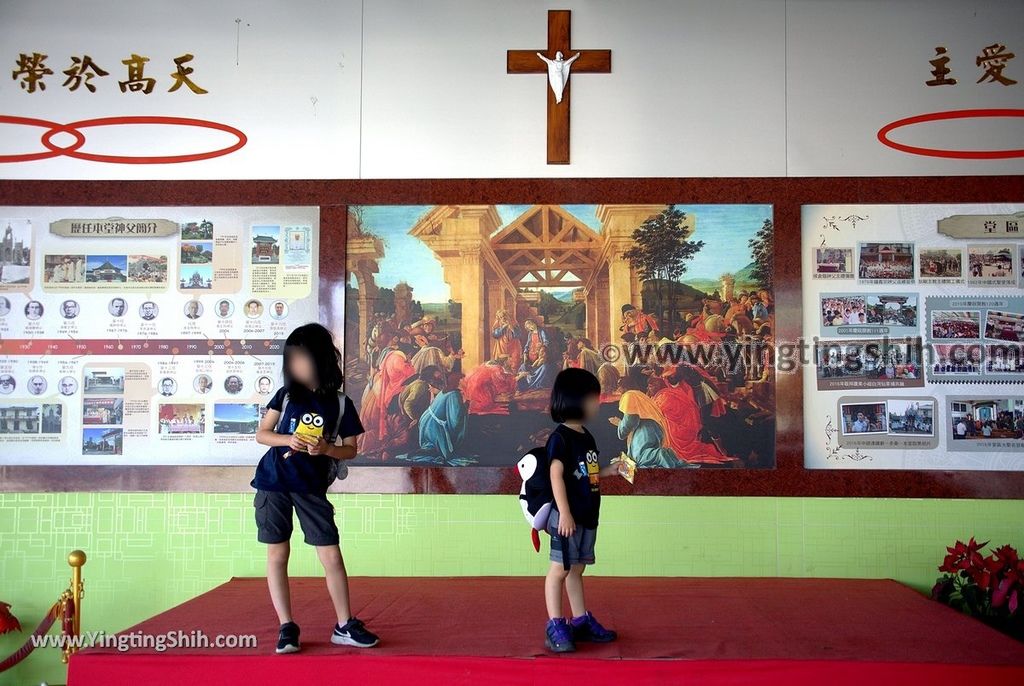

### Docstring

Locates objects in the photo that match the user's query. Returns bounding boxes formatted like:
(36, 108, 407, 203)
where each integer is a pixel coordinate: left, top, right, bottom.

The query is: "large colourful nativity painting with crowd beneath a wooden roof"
(345, 205, 775, 469)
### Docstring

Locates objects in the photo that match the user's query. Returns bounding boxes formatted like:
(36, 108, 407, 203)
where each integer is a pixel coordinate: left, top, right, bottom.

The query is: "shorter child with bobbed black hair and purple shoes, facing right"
(544, 368, 621, 652)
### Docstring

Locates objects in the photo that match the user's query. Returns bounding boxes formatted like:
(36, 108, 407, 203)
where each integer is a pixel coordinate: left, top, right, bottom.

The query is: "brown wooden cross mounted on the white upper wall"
(507, 9, 611, 165)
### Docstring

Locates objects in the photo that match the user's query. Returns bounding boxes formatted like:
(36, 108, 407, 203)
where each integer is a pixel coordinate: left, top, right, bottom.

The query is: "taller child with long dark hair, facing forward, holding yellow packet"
(252, 324, 378, 653)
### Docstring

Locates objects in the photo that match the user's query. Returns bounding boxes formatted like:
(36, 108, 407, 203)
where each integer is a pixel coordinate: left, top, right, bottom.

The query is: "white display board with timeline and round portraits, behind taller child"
(0, 207, 319, 465)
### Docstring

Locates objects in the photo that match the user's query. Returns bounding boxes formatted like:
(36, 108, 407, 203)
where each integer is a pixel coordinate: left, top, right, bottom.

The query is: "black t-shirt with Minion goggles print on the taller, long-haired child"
(252, 388, 362, 494)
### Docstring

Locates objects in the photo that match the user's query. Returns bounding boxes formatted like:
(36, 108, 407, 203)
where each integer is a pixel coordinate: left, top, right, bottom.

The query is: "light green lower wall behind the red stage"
(0, 494, 1024, 686)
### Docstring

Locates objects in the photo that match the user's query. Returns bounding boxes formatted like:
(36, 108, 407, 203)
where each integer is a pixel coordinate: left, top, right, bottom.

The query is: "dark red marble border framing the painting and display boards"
(0, 176, 1024, 499)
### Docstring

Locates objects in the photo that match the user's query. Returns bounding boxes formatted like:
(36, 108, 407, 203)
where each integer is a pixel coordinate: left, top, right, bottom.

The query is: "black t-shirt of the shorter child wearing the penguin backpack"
(547, 424, 601, 528)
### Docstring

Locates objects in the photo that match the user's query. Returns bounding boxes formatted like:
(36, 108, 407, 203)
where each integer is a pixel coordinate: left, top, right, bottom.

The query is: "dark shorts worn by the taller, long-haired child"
(253, 490, 340, 546)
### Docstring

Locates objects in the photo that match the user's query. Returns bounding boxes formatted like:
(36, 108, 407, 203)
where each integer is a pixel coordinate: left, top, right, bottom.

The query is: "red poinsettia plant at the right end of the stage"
(932, 537, 1024, 635)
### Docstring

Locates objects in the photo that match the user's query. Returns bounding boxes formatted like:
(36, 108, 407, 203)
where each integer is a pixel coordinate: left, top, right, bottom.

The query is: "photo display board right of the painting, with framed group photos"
(798, 204, 1024, 471)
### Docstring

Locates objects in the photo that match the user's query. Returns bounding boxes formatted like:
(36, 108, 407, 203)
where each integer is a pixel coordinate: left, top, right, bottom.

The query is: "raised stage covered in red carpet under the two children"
(69, 576, 1024, 686)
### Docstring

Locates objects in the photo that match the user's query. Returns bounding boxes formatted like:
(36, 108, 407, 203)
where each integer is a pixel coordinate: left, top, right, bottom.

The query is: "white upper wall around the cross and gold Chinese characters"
(0, 0, 1024, 178)
